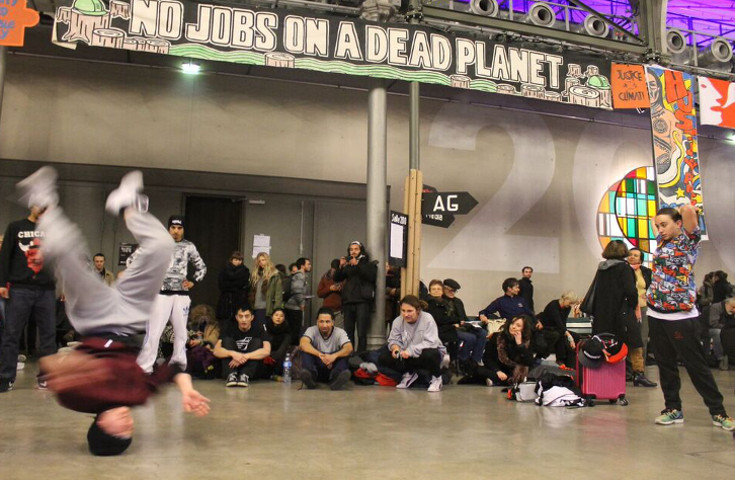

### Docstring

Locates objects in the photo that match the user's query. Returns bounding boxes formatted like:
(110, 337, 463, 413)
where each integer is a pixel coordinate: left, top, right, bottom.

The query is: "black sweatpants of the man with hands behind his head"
(648, 316, 726, 415)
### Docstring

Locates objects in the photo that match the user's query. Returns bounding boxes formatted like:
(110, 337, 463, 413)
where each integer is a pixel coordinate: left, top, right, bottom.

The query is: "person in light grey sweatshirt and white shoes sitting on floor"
(378, 295, 446, 392)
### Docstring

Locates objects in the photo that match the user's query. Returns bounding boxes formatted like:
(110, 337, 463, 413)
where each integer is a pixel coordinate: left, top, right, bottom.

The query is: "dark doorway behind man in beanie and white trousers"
(184, 196, 242, 308)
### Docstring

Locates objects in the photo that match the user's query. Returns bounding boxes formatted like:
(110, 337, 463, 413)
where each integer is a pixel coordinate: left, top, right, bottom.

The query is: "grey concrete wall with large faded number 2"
(0, 56, 735, 312)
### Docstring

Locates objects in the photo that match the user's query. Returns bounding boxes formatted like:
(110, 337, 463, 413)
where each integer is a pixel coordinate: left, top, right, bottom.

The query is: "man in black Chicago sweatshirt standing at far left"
(0, 174, 58, 393)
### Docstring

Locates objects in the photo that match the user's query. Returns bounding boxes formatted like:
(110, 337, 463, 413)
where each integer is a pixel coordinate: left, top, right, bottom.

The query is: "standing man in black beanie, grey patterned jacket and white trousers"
(138, 215, 207, 373)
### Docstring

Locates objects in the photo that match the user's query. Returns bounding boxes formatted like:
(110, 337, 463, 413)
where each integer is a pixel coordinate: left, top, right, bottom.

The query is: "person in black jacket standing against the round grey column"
(334, 240, 378, 352)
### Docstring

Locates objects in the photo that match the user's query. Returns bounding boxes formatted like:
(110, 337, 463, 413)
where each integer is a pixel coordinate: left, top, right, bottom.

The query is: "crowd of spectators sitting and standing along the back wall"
(0, 202, 735, 391)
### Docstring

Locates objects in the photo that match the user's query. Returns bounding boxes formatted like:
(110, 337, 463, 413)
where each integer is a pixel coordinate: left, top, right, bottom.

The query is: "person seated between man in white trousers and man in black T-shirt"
(186, 304, 220, 379)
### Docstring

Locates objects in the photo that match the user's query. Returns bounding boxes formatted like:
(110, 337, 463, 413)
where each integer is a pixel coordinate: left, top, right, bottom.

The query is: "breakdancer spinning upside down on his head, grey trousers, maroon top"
(18, 167, 209, 455)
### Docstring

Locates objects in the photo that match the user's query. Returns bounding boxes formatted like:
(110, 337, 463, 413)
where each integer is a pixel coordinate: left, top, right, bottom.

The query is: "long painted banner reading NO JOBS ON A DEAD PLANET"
(53, 0, 612, 109)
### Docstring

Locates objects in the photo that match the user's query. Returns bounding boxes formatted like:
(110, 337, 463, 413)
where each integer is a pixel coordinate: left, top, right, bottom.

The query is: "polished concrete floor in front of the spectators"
(0, 363, 735, 480)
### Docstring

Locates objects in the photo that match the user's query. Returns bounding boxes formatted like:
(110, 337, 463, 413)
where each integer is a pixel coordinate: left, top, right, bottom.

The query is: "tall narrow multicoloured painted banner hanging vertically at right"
(646, 66, 706, 235)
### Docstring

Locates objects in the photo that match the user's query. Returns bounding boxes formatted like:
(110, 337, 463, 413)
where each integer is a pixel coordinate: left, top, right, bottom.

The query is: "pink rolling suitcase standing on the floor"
(576, 342, 628, 407)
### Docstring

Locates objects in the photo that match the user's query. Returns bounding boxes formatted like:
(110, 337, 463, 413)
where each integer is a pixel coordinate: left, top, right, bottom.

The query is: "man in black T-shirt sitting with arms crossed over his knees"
(214, 307, 271, 387)
